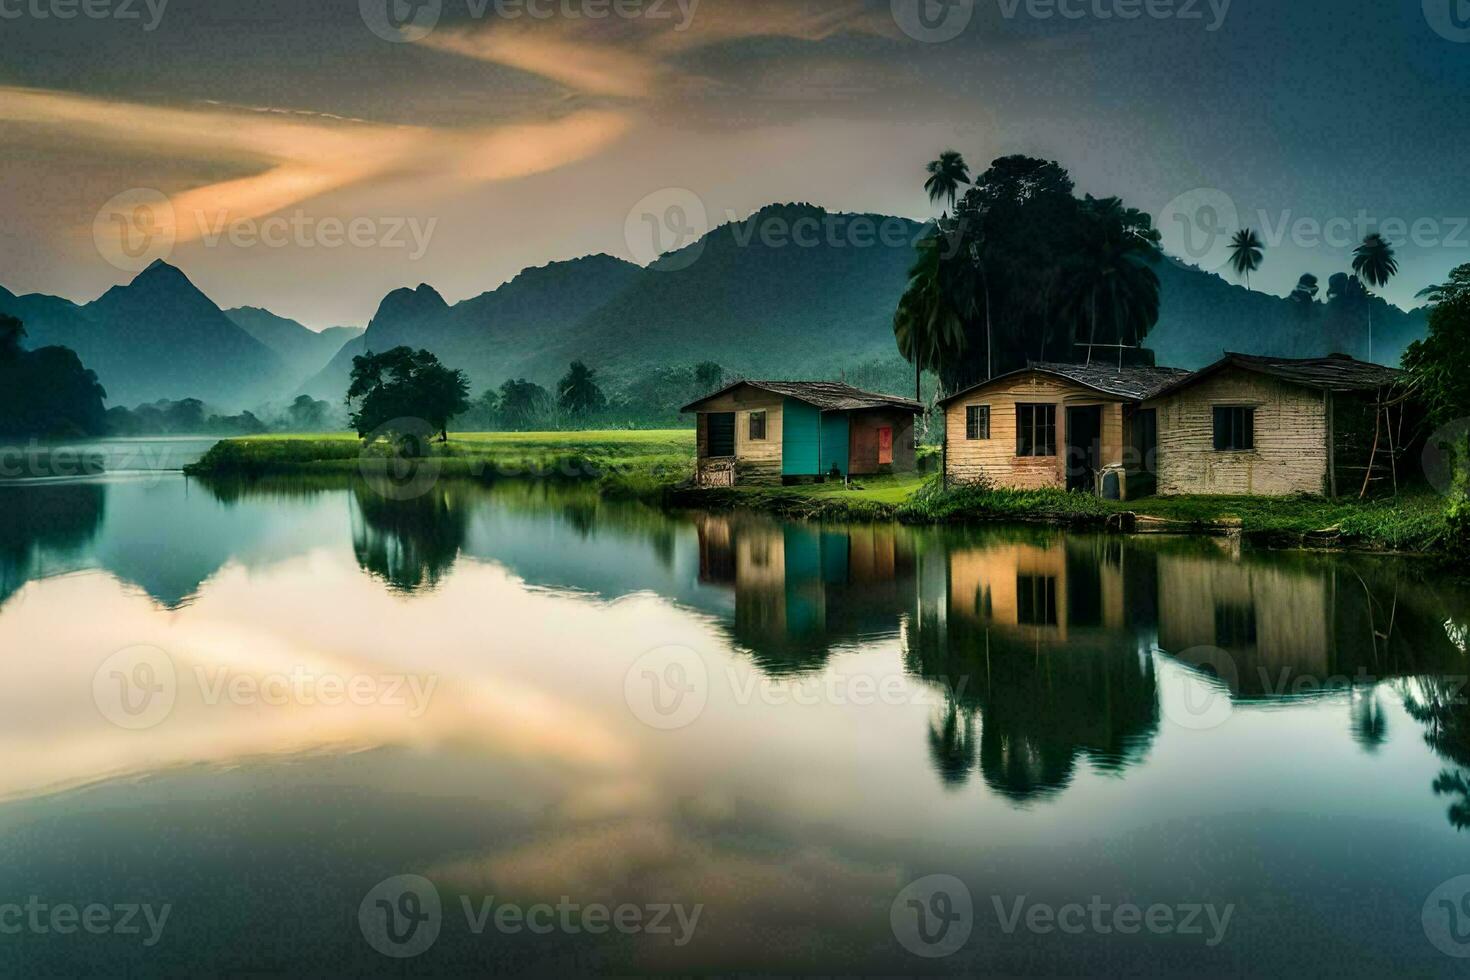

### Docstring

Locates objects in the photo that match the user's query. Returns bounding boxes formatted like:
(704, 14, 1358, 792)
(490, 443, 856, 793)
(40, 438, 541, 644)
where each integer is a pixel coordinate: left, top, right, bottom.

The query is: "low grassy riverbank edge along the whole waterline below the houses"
(184, 433, 1470, 567)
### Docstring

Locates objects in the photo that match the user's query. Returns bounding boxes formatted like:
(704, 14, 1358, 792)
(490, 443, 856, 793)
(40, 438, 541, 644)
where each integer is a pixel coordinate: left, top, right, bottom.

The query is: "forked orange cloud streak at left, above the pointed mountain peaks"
(0, 87, 631, 242)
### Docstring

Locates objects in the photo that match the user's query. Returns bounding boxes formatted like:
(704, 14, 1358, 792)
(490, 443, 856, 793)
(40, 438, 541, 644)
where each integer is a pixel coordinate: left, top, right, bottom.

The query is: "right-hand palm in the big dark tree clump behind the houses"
(1060, 195, 1160, 366)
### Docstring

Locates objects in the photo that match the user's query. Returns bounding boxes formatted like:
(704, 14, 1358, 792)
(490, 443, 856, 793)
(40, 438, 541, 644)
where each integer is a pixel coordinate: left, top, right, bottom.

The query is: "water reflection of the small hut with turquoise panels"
(697, 514, 914, 674)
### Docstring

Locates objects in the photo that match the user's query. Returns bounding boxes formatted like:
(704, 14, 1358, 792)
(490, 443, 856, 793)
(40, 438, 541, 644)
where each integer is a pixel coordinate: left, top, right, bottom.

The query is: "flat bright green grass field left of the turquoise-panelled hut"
(185, 429, 694, 497)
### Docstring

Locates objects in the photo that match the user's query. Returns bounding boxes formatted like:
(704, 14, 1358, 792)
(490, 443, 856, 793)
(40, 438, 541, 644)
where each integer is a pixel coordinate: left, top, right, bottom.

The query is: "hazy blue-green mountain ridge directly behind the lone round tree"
(306, 256, 642, 403)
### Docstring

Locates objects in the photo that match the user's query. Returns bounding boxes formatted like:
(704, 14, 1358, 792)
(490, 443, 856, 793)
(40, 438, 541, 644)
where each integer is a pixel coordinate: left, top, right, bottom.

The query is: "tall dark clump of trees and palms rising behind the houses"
(894, 156, 1160, 391)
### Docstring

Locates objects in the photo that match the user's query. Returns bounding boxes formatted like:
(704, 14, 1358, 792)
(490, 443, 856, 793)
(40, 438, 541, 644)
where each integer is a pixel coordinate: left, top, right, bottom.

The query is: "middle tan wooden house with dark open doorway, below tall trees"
(939, 363, 1189, 498)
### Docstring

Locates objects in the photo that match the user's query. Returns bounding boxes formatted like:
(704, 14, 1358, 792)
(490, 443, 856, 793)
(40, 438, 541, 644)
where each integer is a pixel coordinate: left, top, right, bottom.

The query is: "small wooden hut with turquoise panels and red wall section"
(684, 381, 923, 486)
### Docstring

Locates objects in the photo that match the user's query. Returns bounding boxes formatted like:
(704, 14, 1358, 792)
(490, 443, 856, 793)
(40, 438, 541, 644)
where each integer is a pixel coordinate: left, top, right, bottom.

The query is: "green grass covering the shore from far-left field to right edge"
(188, 429, 1470, 555)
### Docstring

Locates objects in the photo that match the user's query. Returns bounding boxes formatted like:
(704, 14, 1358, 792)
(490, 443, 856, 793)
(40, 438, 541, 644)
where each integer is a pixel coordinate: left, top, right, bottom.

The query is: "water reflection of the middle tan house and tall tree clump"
(907, 530, 1158, 801)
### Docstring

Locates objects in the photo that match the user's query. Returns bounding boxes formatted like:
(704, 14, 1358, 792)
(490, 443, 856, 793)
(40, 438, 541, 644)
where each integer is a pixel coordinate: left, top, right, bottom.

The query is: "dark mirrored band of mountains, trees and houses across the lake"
(0, 478, 1470, 827)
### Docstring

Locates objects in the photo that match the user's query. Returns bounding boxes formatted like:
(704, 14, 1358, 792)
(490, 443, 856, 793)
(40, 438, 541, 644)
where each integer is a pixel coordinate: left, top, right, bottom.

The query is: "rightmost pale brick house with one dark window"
(1142, 354, 1413, 497)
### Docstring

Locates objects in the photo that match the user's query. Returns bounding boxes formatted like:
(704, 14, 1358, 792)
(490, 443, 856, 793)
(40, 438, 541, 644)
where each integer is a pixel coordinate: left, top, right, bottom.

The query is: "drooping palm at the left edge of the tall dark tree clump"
(894, 229, 973, 401)
